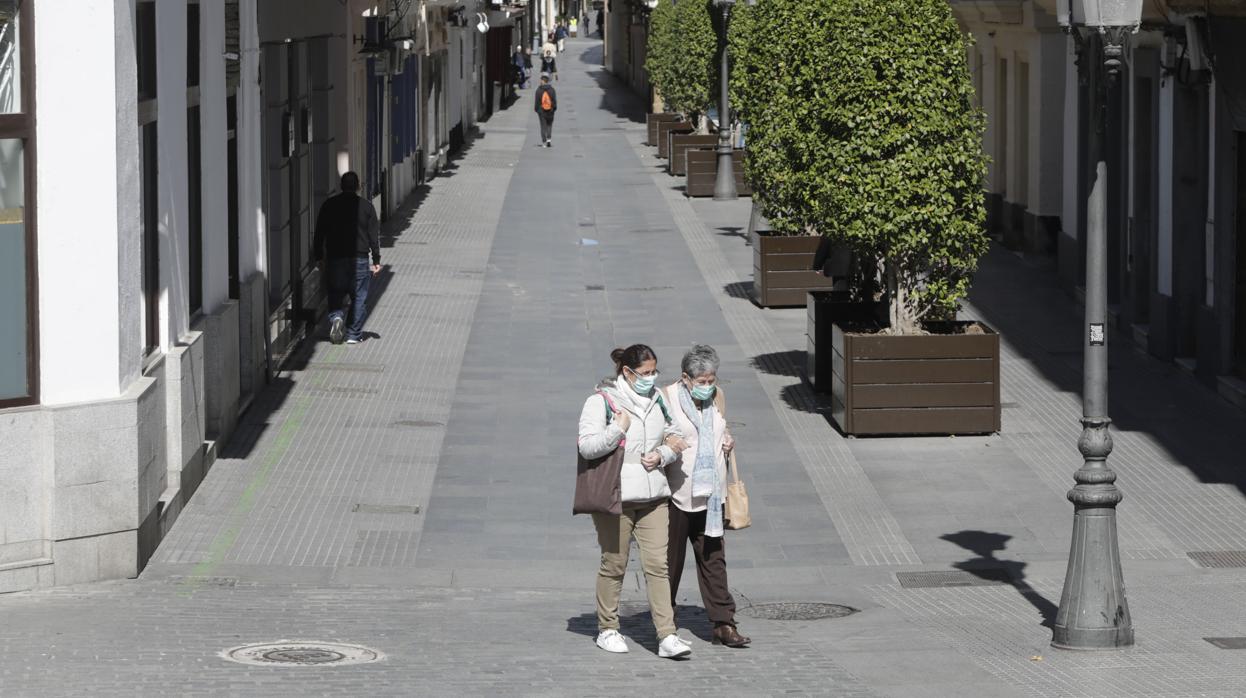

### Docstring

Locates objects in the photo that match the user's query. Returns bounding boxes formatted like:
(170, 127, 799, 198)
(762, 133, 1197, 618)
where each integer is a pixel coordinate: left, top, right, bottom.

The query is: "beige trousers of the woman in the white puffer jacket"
(593, 500, 675, 642)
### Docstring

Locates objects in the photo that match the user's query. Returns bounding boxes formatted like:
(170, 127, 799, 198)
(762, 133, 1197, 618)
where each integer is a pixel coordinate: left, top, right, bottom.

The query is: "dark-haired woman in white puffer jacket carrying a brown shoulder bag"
(579, 344, 692, 658)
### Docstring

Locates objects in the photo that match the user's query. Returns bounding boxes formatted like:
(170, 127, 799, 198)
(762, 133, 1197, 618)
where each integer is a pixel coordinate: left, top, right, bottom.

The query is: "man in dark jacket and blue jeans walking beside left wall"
(313, 172, 381, 344)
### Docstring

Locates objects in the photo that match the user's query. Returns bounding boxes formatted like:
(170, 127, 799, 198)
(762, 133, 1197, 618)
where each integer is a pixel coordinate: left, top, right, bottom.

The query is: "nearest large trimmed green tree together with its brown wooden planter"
(738, 0, 999, 434)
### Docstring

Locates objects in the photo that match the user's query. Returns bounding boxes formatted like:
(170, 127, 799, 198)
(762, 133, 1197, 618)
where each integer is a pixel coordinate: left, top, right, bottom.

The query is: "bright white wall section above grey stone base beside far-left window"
(35, 0, 133, 405)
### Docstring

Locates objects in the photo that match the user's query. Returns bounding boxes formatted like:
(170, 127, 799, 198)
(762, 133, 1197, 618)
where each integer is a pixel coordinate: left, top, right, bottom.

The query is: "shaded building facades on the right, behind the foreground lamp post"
(951, 0, 1246, 405)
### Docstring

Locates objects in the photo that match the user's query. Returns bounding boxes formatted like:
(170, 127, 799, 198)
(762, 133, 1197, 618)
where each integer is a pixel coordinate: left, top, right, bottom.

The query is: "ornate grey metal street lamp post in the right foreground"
(1052, 0, 1143, 649)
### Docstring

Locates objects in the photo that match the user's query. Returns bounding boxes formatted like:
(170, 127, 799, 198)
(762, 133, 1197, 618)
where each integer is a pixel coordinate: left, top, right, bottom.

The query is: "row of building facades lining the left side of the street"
(0, 0, 523, 592)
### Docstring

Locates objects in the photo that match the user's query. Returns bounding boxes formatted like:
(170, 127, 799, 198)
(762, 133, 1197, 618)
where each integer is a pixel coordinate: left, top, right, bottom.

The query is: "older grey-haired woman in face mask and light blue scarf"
(665, 344, 751, 647)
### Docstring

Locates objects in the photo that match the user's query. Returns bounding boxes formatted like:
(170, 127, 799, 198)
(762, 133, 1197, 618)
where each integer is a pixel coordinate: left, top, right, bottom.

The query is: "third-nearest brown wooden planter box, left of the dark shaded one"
(747, 230, 835, 308)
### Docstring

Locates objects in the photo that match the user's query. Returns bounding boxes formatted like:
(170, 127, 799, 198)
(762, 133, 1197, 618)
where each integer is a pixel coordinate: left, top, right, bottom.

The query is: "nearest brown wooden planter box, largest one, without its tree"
(831, 323, 999, 435)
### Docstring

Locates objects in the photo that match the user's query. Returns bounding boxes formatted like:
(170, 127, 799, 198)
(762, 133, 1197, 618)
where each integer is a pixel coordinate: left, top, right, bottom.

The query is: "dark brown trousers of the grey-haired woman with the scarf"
(667, 505, 735, 626)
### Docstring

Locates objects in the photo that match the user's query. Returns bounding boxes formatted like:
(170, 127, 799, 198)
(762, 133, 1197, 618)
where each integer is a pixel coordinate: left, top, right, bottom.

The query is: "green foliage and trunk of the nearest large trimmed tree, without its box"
(734, 0, 988, 334)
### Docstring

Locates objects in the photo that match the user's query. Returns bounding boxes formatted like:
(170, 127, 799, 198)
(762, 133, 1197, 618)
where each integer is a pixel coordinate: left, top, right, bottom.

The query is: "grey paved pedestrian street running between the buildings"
(7, 39, 1246, 698)
